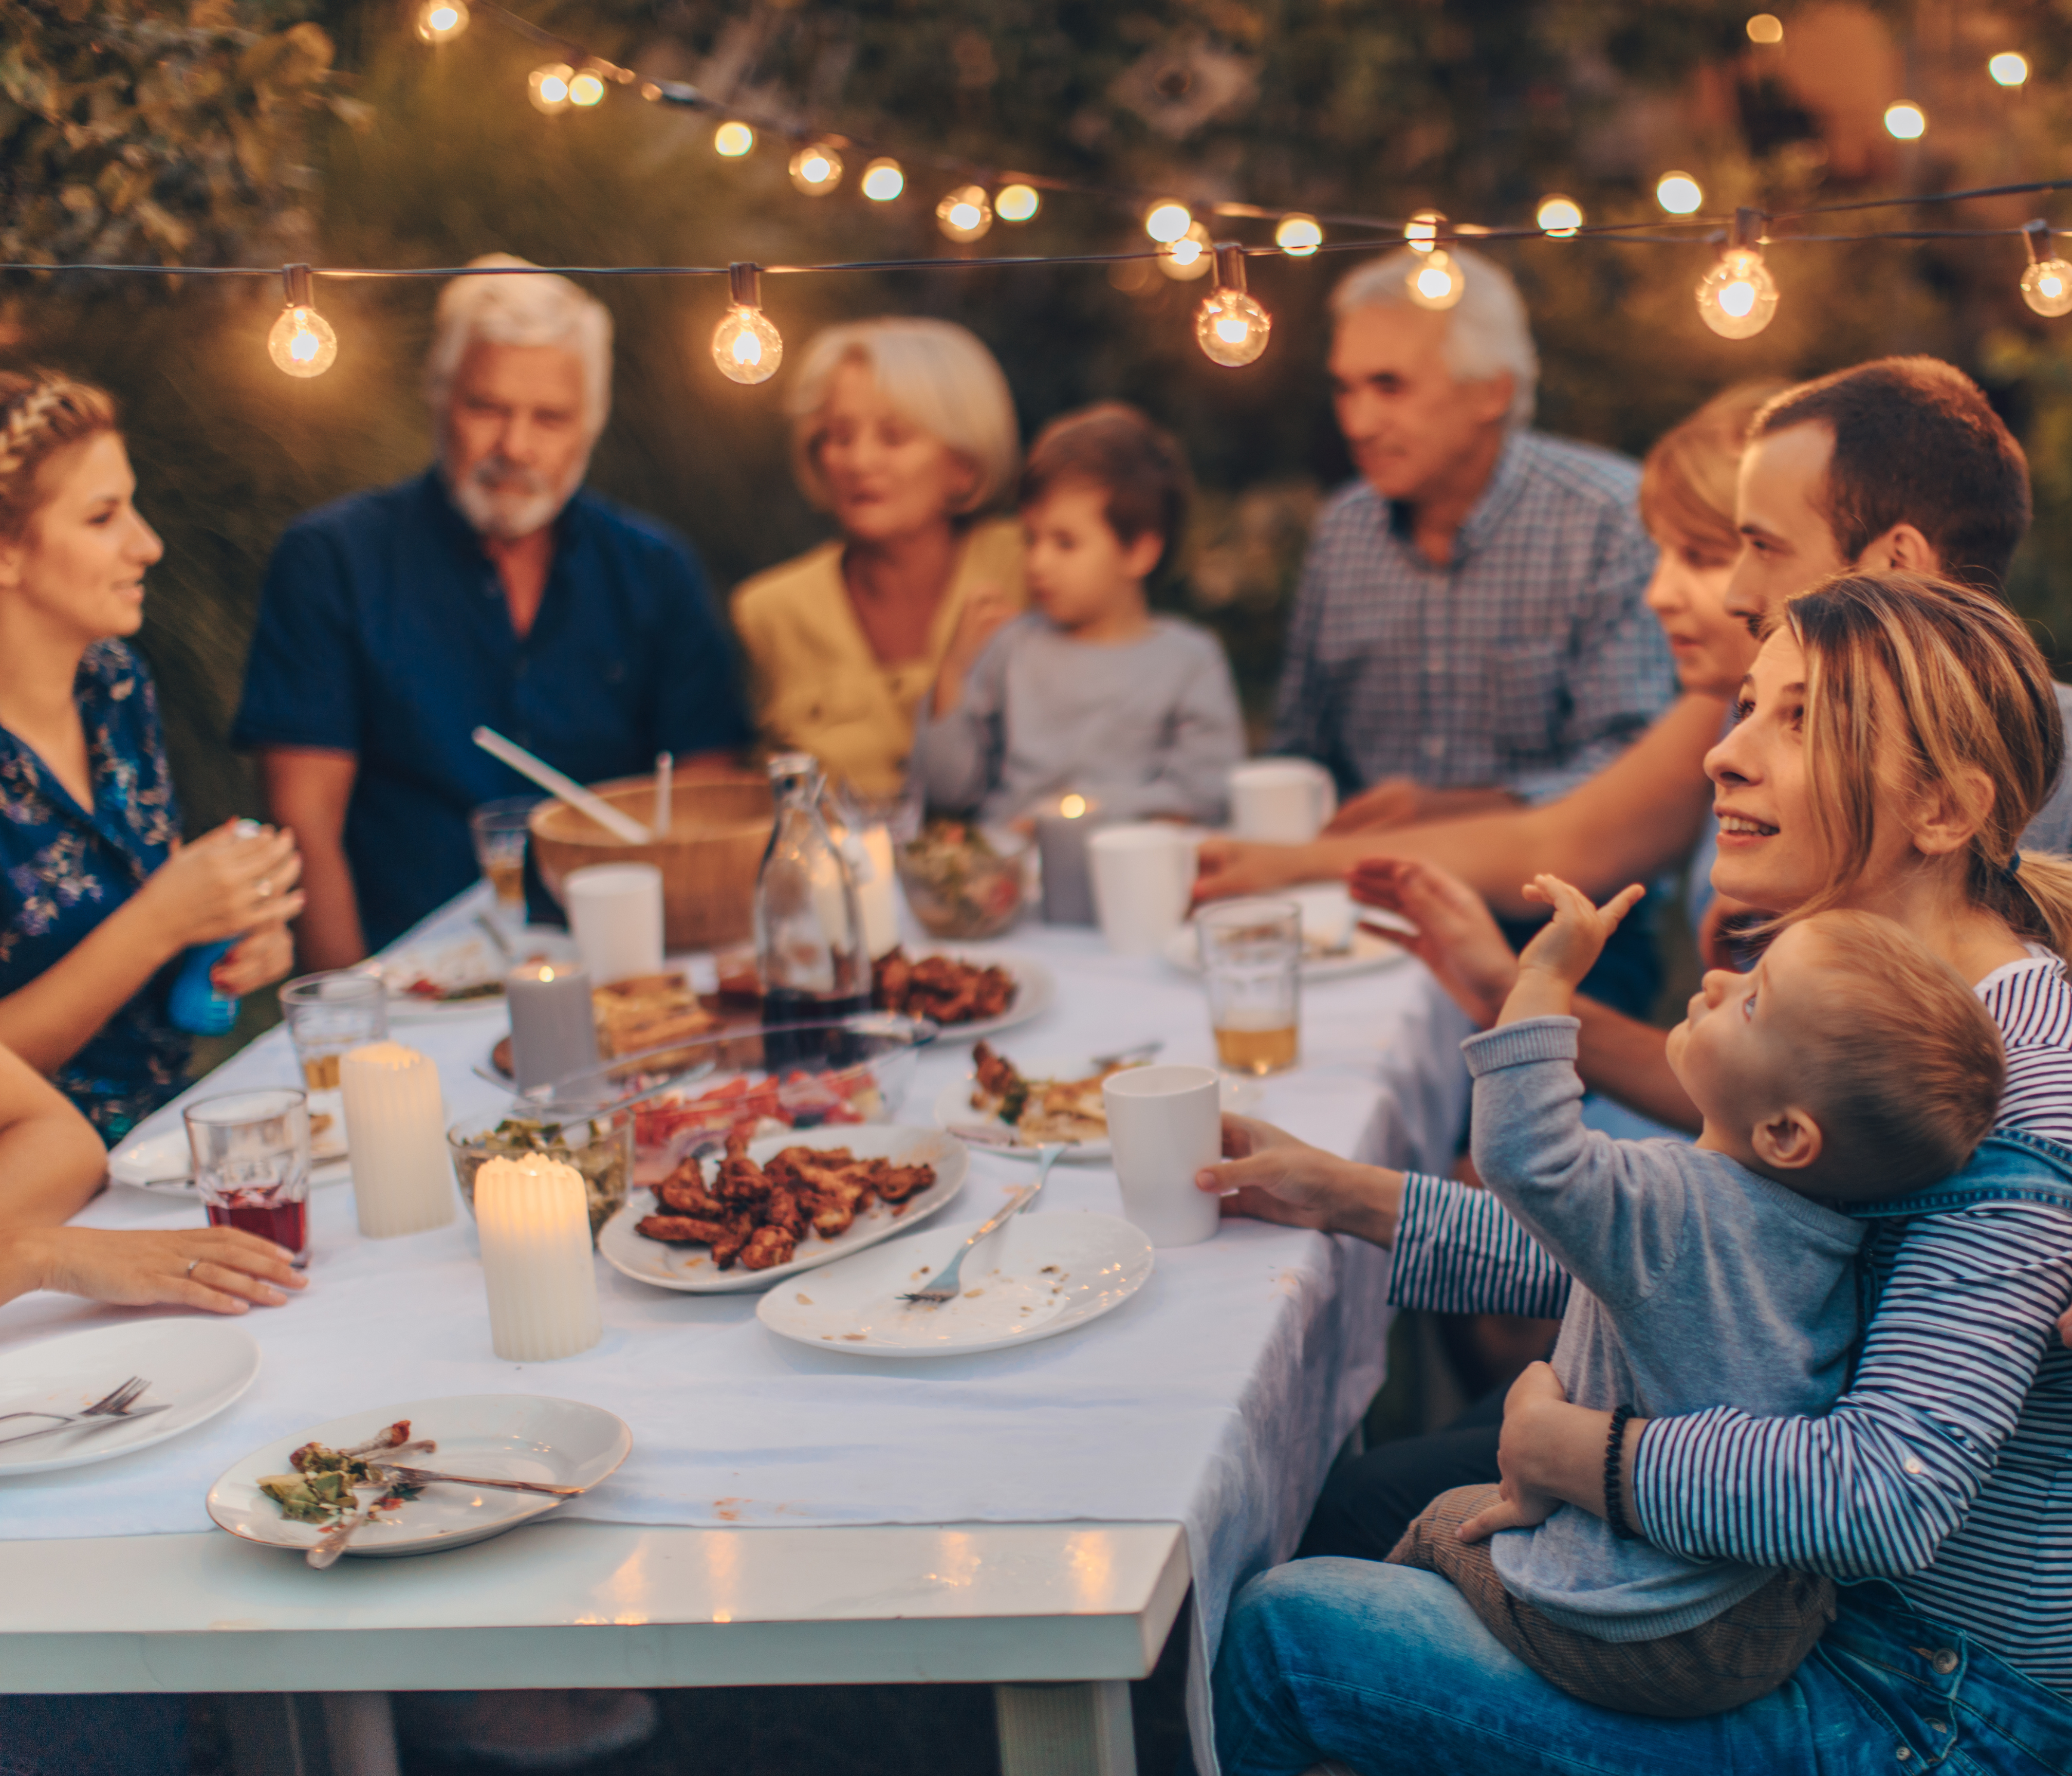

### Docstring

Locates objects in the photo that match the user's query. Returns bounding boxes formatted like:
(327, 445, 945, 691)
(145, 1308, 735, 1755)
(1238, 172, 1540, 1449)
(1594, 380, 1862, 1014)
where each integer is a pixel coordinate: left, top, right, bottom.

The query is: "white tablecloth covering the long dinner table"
(0, 895, 1467, 1768)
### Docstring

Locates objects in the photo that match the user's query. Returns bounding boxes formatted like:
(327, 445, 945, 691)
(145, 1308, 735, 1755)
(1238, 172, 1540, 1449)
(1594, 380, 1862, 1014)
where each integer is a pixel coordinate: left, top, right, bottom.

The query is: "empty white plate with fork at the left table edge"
(0, 1318, 259, 1477)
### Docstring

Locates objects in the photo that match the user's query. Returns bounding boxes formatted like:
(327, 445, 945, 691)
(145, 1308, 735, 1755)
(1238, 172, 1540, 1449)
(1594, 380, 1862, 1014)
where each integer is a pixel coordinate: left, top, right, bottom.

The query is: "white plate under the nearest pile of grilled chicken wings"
(597, 1123, 972, 1295)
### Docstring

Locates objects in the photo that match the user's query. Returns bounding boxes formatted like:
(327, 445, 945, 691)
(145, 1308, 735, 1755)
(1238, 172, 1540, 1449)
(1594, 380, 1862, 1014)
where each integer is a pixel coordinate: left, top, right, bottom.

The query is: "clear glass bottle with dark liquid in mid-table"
(756, 752, 870, 1052)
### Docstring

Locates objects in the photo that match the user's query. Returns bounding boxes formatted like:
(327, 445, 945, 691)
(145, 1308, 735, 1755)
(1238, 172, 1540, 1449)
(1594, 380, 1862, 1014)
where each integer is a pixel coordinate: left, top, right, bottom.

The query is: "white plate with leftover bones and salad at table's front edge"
(209, 1395, 634, 1555)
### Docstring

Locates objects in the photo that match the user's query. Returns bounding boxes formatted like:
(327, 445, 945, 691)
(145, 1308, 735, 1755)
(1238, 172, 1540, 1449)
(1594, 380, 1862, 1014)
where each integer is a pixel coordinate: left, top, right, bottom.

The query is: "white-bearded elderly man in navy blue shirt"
(232, 253, 750, 968)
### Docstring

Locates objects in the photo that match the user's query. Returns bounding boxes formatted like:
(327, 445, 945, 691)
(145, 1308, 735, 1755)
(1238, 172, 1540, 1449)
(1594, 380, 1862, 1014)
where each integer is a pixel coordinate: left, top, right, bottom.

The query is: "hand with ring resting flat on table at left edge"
(0, 1227, 307, 1314)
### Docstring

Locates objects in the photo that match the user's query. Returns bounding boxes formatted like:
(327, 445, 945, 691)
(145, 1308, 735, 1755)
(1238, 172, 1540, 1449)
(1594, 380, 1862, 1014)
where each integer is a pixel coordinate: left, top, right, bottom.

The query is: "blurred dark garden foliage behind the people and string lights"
(0, 0, 2072, 827)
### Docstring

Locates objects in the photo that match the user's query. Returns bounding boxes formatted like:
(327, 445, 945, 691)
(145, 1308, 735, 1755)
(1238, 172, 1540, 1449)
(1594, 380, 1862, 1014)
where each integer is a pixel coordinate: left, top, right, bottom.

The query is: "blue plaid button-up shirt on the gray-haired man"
(1272, 431, 1676, 802)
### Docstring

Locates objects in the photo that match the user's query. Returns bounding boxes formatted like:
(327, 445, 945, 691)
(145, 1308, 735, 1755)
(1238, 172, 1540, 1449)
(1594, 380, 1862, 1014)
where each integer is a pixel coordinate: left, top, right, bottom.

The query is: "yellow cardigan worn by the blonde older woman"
(733, 518, 1026, 796)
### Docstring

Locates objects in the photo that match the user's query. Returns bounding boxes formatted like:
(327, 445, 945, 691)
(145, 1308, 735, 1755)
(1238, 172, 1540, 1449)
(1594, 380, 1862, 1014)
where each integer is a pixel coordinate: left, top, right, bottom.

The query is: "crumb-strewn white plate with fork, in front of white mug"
(756, 1210, 1152, 1357)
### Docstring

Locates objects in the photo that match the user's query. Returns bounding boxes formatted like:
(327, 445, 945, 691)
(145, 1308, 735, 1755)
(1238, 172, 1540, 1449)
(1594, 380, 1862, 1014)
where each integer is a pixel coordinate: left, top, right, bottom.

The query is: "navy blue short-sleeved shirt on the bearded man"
(232, 468, 750, 949)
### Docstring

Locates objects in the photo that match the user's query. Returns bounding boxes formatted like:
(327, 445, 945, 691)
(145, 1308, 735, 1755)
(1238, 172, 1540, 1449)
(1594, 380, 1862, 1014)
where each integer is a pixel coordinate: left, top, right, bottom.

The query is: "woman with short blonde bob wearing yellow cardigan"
(733, 317, 1024, 796)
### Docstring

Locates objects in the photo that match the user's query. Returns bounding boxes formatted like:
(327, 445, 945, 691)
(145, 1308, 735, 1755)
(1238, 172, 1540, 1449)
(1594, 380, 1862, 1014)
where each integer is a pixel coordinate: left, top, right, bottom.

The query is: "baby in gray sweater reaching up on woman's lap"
(1388, 877, 2006, 1716)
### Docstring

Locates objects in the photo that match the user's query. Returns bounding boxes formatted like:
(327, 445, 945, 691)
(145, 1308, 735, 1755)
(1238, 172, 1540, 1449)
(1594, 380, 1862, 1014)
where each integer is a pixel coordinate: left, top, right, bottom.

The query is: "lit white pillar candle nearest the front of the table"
(474, 1152, 605, 1363)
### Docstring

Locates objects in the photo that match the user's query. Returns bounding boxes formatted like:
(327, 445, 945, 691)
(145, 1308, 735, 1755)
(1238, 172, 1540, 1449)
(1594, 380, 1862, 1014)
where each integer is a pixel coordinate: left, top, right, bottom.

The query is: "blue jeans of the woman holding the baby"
(1214, 1559, 2072, 1776)
